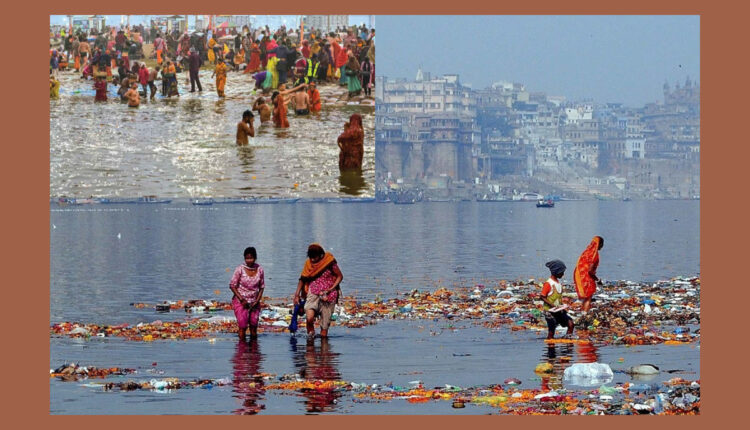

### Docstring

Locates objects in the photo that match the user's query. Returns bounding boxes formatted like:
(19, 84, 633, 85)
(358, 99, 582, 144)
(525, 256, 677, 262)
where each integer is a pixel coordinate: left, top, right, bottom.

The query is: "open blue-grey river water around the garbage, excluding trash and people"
(50, 201, 700, 414)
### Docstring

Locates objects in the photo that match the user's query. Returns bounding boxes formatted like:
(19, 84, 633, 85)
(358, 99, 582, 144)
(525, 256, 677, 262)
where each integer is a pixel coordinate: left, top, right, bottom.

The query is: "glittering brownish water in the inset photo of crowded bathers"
(50, 71, 375, 197)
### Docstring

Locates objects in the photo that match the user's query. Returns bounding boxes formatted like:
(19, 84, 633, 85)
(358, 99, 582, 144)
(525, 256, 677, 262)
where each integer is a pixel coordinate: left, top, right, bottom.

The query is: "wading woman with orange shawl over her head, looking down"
(294, 243, 344, 338)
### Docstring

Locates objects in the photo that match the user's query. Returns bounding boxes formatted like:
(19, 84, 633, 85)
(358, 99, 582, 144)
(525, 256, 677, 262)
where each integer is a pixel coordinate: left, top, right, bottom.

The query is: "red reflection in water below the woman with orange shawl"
(289, 336, 341, 414)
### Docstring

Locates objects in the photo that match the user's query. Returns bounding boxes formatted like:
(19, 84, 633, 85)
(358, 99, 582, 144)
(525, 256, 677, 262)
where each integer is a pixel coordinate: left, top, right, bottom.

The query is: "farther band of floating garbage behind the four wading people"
(50, 278, 700, 346)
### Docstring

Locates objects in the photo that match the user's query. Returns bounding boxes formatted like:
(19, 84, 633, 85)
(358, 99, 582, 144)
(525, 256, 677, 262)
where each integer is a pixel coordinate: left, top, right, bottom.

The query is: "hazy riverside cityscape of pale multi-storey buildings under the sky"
(375, 69, 700, 200)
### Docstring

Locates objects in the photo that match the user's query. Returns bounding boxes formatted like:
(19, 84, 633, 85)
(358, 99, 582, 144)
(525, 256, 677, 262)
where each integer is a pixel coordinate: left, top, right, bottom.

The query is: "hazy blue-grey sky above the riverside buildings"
(377, 15, 700, 106)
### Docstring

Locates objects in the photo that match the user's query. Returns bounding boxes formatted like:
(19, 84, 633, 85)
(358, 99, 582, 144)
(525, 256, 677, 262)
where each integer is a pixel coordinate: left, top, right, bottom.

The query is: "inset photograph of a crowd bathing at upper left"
(50, 15, 375, 201)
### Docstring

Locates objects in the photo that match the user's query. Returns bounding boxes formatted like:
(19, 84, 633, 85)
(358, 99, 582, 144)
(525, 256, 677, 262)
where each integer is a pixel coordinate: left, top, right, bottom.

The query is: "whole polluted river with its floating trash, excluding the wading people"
(50, 200, 701, 415)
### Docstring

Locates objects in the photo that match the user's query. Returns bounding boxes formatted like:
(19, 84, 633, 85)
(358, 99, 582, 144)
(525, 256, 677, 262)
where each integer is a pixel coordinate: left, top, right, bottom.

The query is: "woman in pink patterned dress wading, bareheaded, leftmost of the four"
(229, 246, 266, 340)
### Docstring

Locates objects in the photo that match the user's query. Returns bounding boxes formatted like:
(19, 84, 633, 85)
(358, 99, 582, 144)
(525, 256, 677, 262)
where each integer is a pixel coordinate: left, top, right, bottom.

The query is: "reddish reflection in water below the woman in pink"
(232, 339, 266, 415)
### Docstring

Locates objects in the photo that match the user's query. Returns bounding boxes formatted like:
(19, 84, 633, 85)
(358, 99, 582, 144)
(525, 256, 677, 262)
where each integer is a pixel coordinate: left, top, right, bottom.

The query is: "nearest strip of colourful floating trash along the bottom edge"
(51, 365, 700, 415)
